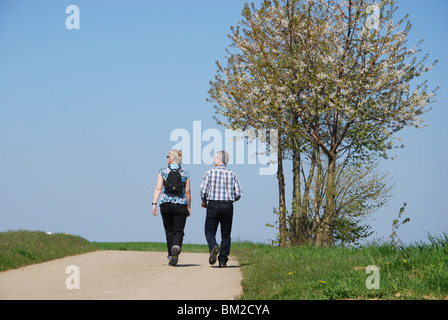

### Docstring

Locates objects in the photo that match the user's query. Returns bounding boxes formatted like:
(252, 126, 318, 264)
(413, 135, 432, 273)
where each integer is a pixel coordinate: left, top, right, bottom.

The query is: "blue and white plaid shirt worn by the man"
(201, 164, 243, 203)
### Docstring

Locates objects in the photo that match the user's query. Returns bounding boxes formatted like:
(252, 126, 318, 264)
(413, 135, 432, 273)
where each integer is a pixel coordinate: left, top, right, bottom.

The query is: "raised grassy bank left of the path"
(0, 230, 98, 272)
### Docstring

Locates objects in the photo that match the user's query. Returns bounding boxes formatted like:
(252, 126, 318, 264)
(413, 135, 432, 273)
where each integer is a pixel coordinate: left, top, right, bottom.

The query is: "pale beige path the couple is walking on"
(0, 251, 242, 300)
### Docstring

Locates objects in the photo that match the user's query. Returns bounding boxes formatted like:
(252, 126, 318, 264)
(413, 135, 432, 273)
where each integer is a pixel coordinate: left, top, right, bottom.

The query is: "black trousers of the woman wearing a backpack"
(160, 203, 188, 255)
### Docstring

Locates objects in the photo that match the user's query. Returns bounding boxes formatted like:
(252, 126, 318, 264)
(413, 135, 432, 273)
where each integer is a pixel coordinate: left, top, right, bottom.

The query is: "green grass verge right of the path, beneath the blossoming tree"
(232, 235, 448, 300)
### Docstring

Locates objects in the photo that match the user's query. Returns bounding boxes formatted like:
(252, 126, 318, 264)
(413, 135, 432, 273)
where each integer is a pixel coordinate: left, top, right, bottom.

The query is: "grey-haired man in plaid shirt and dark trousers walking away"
(201, 151, 242, 268)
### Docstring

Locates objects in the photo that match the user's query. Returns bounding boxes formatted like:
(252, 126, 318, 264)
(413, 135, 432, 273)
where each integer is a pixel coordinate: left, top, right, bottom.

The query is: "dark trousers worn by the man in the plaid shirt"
(204, 201, 233, 263)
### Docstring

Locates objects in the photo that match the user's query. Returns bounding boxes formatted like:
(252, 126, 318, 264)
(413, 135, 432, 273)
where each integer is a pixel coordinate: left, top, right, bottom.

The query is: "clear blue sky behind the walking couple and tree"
(0, 0, 448, 243)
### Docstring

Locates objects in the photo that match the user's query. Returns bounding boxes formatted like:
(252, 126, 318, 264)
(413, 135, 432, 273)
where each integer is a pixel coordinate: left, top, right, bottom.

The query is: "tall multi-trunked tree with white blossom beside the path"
(209, 0, 436, 246)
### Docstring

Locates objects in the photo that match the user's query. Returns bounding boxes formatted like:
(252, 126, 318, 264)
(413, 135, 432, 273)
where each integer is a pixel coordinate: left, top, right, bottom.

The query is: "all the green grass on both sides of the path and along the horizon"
(0, 231, 448, 300)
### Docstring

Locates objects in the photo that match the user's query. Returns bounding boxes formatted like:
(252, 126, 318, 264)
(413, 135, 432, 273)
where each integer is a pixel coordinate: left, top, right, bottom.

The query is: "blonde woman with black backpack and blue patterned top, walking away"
(152, 150, 191, 266)
